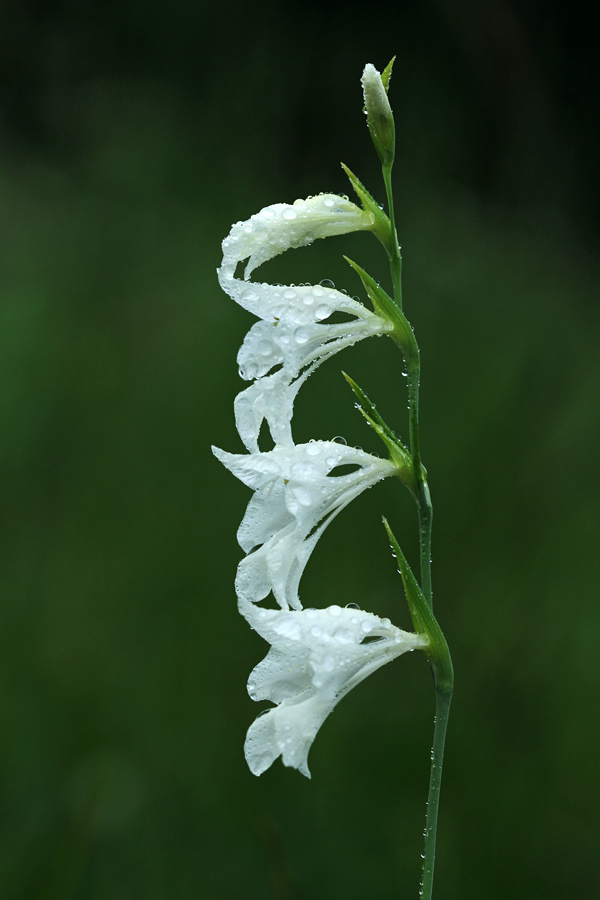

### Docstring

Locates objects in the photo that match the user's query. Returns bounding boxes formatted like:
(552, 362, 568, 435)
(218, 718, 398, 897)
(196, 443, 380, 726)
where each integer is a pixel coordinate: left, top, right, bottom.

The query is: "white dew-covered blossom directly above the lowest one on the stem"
(213, 441, 397, 609)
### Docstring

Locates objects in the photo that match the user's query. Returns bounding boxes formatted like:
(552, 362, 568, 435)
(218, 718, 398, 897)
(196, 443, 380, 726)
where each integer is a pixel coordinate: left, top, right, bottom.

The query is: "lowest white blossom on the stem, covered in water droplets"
(240, 602, 428, 778)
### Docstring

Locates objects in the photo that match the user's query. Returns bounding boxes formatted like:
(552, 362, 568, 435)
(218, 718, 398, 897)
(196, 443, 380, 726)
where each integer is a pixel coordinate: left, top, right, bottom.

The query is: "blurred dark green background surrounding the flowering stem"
(0, 0, 600, 900)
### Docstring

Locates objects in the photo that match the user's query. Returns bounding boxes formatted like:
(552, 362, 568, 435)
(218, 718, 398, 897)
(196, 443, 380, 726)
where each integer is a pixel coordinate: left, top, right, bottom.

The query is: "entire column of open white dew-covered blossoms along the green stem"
(213, 188, 427, 777)
